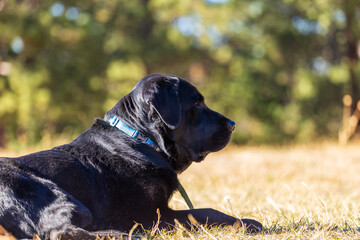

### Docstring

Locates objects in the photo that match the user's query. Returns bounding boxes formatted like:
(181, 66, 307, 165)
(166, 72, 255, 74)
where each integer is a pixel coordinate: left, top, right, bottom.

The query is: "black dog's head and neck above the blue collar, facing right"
(105, 74, 235, 172)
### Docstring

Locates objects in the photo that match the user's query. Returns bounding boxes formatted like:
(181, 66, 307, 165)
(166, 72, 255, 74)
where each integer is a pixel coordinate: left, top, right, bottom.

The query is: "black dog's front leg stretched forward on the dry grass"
(160, 208, 263, 232)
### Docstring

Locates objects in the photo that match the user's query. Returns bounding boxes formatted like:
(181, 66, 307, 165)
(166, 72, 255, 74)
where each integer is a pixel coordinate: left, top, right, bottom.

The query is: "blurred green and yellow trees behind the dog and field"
(0, 0, 360, 148)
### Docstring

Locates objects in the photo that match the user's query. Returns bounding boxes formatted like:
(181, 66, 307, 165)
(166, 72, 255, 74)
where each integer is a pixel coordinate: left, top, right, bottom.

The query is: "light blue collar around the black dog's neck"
(109, 116, 161, 152)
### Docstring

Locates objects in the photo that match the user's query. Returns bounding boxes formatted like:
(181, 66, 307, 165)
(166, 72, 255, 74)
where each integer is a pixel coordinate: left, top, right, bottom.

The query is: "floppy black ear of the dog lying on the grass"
(145, 76, 181, 129)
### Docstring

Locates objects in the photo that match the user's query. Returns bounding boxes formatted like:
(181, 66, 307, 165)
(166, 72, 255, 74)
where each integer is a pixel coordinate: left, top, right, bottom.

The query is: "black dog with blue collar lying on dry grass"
(0, 75, 262, 239)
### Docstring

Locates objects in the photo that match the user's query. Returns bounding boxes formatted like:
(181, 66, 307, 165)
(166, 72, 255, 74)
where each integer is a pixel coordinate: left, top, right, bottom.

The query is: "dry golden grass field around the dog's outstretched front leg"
(2, 143, 360, 239)
